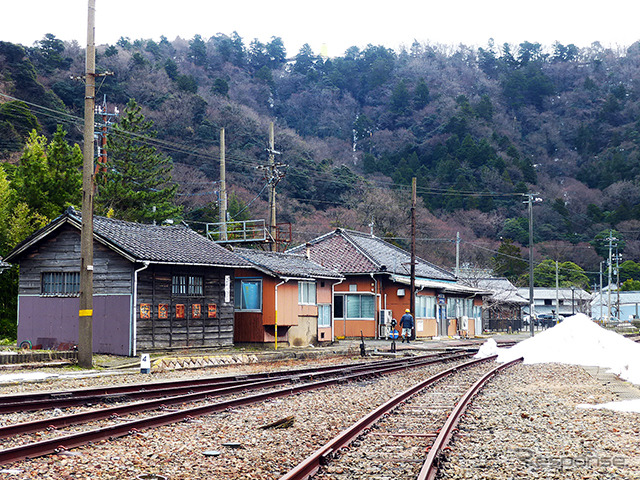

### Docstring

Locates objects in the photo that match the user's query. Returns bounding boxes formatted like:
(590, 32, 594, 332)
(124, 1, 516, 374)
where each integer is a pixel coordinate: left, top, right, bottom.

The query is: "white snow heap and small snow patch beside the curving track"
(476, 313, 640, 413)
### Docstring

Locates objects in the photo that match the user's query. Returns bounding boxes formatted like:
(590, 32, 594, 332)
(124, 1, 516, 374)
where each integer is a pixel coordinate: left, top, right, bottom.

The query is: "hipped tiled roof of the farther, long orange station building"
(290, 229, 456, 281)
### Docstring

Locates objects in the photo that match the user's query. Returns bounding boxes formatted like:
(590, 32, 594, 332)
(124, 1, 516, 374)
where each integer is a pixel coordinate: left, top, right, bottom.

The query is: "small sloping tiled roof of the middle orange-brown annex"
(234, 248, 341, 279)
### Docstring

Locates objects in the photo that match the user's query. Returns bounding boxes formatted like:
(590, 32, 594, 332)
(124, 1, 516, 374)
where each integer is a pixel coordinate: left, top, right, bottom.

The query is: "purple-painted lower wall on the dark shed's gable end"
(18, 295, 131, 355)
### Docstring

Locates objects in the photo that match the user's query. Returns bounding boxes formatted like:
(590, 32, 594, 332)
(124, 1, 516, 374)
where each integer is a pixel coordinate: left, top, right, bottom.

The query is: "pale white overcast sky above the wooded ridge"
(0, 0, 640, 57)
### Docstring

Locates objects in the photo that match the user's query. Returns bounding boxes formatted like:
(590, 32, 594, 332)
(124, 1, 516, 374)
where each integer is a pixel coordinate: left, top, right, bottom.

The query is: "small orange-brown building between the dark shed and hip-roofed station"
(234, 248, 342, 346)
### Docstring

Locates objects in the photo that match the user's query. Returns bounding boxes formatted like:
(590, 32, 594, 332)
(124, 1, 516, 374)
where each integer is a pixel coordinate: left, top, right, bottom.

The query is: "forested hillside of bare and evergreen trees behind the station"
(0, 33, 640, 284)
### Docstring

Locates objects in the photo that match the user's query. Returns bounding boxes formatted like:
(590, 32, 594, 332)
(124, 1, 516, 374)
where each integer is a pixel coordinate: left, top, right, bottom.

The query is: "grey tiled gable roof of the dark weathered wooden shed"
(9, 209, 250, 267)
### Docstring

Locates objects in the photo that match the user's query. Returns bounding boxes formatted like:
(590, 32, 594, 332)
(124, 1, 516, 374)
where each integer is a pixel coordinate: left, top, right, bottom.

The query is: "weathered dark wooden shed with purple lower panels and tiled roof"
(7, 209, 249, 355)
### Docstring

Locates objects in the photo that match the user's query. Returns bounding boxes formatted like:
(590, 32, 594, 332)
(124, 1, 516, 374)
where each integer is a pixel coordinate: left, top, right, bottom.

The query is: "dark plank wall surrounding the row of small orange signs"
(136, 265, 234, 351)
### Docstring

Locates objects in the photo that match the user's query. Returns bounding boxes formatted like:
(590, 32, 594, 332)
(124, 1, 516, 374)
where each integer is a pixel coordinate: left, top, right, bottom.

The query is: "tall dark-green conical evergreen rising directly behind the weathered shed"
(96, 99, 181, 222)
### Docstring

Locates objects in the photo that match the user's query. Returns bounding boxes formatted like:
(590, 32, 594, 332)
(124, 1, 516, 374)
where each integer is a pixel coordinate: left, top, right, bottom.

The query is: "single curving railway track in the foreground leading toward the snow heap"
(280, 357, 522, 480)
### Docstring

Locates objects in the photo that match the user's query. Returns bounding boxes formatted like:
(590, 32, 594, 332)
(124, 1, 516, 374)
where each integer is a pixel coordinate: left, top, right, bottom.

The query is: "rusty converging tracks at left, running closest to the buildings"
(0, 352, 472, 464)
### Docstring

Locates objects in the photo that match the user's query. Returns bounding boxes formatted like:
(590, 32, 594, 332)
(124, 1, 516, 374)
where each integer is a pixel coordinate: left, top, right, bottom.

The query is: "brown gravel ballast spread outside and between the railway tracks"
(0, 358, 640, 480)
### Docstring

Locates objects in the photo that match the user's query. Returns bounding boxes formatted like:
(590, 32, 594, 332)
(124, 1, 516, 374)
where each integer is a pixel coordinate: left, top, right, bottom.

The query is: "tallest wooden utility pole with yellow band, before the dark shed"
(78, 0, 96, 368)
